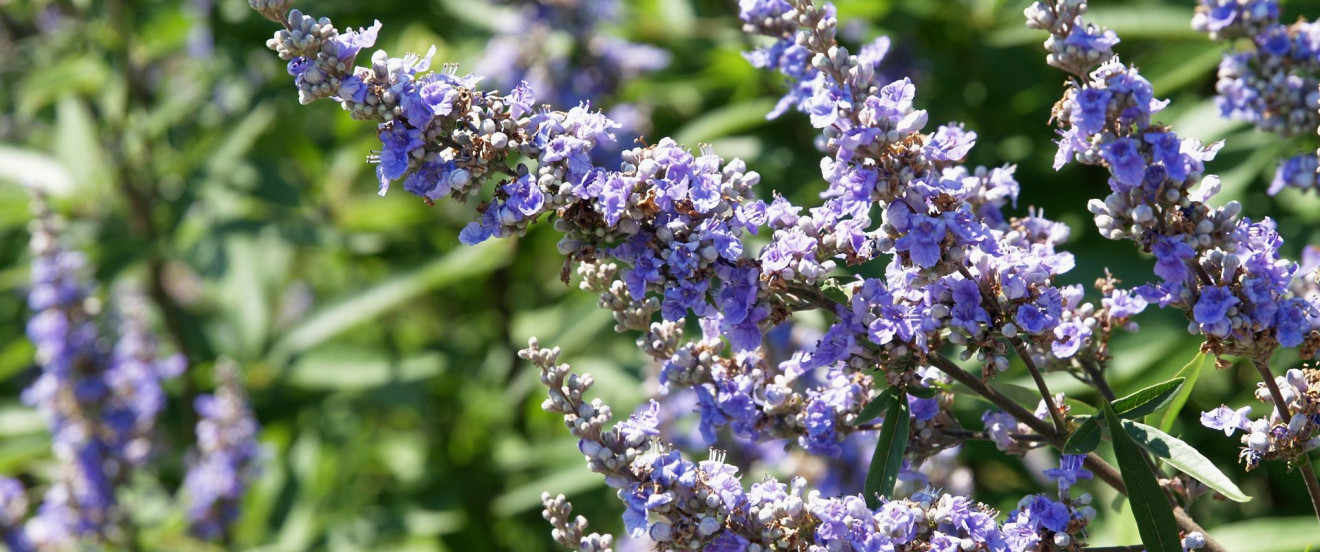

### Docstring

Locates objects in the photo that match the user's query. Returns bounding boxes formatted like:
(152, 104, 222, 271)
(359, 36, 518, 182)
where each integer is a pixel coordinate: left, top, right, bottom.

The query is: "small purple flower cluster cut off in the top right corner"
(1192, 0, 1320, 195)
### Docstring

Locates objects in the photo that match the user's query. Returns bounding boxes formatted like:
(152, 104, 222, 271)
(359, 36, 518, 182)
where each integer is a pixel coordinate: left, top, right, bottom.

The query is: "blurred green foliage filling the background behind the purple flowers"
(0, 0, 1320, 552)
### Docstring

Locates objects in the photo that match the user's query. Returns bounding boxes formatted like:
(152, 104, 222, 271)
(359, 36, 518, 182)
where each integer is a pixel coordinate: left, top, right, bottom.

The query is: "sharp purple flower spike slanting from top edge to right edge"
(1027, 0, 1320, 357)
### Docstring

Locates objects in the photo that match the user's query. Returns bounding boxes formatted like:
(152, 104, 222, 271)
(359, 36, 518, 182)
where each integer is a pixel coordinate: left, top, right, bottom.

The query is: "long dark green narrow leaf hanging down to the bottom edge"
(1105, 403, 1183, 552)
